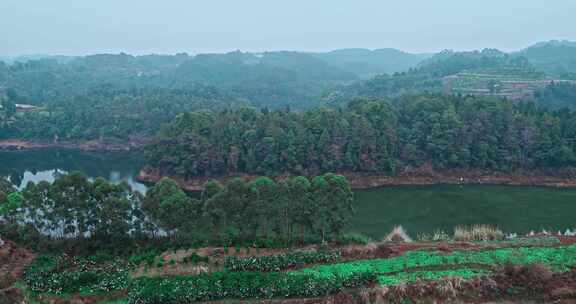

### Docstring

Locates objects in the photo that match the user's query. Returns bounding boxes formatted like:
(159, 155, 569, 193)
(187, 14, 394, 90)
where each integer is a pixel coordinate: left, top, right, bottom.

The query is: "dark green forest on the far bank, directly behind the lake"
(146, 94, 576, 178)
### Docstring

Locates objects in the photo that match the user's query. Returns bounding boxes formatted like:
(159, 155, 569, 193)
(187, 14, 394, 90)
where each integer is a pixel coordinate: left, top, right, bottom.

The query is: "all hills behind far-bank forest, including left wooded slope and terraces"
(0, 43, 576, 142)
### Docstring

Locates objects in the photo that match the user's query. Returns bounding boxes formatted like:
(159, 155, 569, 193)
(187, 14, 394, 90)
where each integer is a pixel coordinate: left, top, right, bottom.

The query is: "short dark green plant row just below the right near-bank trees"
(224, 252, 340, 272)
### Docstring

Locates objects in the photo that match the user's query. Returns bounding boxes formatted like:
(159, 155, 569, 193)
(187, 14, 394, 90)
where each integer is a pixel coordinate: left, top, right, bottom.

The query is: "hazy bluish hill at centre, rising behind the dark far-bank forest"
(166, 52, 357, 108)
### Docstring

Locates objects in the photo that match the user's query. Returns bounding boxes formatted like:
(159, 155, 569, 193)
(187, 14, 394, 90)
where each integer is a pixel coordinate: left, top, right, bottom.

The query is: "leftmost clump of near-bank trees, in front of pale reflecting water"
(11, 172, 144, 242)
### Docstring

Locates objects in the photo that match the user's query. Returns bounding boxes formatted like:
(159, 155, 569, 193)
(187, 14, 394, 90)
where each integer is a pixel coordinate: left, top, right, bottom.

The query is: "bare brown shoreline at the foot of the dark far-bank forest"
(136, 168, 576, 191)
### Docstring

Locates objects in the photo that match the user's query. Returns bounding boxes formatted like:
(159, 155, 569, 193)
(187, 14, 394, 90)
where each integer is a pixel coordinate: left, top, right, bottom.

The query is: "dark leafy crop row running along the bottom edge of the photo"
(128, 272, 376, 304)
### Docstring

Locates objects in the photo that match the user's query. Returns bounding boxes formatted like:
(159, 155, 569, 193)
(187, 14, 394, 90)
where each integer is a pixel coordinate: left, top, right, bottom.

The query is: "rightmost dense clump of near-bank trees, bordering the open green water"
(203, 174, 353, 243)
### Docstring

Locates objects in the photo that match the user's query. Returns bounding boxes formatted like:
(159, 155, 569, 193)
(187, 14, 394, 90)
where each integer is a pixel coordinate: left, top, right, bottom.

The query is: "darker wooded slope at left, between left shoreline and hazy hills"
(0, 85, 243, 141)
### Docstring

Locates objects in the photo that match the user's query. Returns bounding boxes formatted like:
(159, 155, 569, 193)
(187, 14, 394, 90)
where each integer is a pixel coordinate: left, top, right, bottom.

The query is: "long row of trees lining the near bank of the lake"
(0, 172, 354, 245)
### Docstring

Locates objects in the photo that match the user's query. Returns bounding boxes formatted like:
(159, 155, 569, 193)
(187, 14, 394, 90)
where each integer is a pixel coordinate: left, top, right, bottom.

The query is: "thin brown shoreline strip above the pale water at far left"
(0, 139, 144, 152)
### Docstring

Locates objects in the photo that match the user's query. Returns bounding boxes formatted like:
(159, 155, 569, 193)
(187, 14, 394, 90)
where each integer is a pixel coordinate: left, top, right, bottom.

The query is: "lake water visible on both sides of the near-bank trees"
(0, 150, 576, 239)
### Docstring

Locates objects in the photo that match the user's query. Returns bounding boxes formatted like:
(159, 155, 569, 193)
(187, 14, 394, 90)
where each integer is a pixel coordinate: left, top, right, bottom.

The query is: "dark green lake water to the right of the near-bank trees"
(353, 185, 576, 239)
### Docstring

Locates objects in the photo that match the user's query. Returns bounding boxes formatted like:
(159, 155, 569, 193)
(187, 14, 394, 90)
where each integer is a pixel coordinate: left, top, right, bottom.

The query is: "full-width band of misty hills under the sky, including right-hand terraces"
(0, 41, 576, 108)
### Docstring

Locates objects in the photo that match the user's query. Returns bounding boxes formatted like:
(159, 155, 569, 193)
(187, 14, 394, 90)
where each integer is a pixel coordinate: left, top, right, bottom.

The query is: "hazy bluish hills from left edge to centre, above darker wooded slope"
(0, 52, 356, 107)
